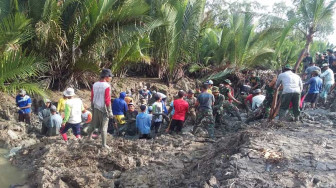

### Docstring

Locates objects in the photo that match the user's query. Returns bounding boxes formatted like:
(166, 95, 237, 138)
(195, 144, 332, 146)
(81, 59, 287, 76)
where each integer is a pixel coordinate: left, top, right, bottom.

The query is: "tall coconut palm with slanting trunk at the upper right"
(294, 0, 336, 71)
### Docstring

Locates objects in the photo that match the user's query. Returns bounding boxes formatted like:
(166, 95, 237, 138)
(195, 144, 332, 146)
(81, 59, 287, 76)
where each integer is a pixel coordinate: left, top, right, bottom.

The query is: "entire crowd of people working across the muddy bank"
(16, 50, 336, 144)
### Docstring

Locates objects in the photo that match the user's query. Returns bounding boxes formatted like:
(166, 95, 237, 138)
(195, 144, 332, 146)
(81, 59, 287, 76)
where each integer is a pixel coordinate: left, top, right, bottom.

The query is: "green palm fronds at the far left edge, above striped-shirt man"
(0, 13, 47, 95)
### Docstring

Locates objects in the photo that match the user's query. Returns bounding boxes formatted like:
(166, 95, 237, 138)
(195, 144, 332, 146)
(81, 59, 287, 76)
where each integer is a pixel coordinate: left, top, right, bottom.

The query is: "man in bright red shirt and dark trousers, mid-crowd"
(168, 90, 189, 133)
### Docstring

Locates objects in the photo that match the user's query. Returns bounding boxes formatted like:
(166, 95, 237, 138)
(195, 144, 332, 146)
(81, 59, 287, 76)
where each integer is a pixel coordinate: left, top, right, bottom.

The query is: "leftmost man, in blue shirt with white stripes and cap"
(15, 89, 32, 125)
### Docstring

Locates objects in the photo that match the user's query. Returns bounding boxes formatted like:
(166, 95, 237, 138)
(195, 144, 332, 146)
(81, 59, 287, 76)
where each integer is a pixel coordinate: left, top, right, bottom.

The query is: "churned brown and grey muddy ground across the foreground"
(0, 77, 336, 188)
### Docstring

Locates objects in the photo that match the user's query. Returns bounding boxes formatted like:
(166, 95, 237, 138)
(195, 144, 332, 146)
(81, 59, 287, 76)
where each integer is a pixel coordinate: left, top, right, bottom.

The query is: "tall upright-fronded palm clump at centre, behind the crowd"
(149, 0, 205, 83)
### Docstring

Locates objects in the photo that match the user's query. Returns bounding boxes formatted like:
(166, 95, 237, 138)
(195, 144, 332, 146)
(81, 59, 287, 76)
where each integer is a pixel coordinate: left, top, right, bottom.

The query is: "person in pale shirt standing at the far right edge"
(320, 63, 335, 104)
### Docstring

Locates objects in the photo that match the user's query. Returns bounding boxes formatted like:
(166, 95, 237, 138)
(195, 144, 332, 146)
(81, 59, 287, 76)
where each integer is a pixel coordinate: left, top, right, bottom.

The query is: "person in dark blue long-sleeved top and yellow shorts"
(112, 92, 128, 135)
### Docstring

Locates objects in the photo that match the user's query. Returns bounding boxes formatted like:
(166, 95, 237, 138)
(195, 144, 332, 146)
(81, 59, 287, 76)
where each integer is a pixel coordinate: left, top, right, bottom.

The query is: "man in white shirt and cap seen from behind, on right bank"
(276, 65, 303, 121)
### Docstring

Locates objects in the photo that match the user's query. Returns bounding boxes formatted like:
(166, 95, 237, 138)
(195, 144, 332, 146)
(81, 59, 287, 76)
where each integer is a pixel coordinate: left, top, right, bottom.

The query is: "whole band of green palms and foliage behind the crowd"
(0, 0, 335, 93)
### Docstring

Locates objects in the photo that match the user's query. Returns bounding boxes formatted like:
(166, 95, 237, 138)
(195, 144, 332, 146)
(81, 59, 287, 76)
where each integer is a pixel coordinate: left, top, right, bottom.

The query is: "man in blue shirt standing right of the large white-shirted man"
(304, 70, 323, 108)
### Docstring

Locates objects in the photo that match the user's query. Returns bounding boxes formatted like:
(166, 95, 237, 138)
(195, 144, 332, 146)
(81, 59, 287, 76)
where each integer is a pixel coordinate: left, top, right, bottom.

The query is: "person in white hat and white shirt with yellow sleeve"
(60, 88, 84, 142)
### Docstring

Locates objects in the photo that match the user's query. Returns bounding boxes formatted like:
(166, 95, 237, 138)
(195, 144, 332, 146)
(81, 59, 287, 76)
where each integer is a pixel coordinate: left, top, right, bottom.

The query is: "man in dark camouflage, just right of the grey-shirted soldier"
(212, 86, 227, 130)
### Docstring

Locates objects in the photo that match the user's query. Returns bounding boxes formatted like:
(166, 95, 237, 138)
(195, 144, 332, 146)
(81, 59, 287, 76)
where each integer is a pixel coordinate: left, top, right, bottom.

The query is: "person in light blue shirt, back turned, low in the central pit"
(136, 105, 152, 139)
